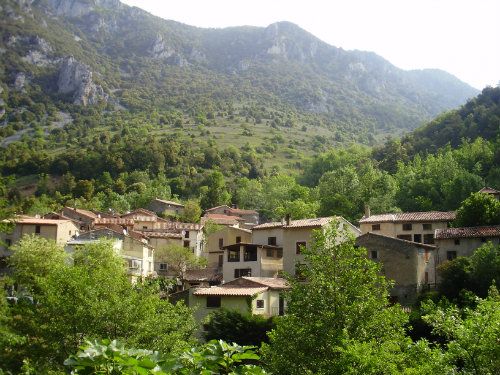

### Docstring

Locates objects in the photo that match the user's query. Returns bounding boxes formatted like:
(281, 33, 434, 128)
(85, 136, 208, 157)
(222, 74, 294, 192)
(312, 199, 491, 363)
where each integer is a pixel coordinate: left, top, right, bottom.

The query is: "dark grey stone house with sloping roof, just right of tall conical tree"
(356, 233, 437, 305)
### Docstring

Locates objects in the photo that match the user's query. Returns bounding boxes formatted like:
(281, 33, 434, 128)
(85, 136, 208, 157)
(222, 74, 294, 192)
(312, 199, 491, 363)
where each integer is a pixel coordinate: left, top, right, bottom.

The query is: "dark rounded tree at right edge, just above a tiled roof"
(453, 193, 500, 227)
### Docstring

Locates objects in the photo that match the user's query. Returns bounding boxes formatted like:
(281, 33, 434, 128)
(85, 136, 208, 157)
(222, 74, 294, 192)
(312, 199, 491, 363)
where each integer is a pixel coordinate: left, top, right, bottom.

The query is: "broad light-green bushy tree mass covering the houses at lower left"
(8, 238, 196, 370)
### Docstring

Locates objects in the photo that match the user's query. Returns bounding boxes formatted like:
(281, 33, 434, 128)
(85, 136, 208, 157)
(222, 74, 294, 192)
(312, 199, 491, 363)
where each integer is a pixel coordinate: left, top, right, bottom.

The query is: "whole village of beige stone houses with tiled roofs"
(0, 187, 500, 321)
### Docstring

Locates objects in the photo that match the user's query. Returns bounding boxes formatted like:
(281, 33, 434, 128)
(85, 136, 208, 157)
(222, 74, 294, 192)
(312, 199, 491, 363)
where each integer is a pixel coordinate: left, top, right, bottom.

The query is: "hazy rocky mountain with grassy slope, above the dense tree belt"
(0, 0, 478, 167)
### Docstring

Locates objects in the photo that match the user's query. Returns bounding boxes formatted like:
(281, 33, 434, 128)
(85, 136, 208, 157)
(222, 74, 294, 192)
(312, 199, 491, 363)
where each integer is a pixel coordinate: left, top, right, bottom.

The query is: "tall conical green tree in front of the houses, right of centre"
(264, 223, 407, 374)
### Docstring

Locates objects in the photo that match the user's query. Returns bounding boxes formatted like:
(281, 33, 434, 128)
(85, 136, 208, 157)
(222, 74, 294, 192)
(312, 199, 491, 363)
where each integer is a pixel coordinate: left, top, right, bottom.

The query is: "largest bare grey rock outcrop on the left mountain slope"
(57, 56, 108, 105)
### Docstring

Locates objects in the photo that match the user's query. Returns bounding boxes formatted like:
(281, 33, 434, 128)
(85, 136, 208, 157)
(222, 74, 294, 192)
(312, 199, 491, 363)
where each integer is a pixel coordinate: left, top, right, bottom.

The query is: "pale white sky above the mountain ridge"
(121, 0, 500, 90)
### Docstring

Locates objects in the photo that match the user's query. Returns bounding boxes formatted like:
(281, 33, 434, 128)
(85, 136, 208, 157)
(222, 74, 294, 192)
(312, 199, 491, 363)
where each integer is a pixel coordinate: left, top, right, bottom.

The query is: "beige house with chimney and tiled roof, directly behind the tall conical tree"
(254, 217, 361, 275)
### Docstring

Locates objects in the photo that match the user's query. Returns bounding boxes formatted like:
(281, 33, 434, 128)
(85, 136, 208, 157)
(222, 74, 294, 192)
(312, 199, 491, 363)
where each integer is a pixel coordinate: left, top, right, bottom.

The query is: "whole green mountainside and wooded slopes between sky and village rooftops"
(0, 0, 494, 222)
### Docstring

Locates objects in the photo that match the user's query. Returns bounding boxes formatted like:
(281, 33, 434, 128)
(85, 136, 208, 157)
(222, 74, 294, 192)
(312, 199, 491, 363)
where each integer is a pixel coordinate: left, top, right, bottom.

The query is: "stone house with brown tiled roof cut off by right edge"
(435, 225, 500, 264)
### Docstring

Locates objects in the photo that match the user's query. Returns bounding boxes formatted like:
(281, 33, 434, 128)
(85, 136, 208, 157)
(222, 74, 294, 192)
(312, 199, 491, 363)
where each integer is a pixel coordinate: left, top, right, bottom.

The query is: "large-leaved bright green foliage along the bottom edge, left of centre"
(64, 340, 266, 375)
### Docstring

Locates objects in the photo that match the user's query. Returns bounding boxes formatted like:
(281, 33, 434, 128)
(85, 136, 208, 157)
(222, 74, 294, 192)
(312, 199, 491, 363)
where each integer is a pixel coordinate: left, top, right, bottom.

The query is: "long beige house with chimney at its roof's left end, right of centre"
(359, 207, 455, 245)
